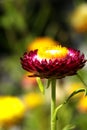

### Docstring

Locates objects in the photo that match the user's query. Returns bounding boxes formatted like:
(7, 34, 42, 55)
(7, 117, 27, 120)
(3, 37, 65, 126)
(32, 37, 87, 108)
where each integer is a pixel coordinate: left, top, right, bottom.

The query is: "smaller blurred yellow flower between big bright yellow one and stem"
(23, 92, 44, 109)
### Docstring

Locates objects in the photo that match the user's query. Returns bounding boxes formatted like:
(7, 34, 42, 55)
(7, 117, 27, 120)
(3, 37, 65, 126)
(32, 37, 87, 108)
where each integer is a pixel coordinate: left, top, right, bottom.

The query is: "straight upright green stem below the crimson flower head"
(51, 79, 56, 130)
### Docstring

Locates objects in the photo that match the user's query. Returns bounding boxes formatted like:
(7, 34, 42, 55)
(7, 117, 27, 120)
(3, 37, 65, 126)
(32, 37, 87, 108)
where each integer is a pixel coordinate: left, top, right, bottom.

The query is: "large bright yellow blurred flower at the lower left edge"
(0, 96, 25, 125)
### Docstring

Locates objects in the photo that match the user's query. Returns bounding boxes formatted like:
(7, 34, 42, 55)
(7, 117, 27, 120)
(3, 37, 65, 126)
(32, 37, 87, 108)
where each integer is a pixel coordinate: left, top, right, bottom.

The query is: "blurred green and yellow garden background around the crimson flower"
(0, 0, 87, 130)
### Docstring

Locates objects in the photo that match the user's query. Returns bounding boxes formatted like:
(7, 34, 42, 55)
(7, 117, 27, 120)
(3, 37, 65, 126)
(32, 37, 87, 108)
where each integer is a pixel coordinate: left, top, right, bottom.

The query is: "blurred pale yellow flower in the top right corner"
(70, 3, 87, 32)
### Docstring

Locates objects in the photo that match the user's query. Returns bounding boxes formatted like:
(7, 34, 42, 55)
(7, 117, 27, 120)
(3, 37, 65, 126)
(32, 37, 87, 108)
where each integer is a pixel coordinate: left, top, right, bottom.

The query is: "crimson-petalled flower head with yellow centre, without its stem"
(21, 45, 86, 78)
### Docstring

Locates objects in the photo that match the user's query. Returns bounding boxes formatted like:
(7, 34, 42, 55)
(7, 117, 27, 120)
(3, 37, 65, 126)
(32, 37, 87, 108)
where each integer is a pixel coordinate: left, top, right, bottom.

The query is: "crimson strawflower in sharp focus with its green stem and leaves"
(21, 45, 86, 130)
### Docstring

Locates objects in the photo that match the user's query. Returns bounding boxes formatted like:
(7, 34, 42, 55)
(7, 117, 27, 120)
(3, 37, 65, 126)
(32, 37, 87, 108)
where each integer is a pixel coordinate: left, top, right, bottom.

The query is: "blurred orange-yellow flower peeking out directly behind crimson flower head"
(28, 37, 58, 50)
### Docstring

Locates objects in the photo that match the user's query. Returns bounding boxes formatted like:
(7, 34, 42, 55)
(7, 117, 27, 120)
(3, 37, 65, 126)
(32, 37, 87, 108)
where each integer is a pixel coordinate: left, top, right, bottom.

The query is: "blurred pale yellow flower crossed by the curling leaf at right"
(66, 82, 84, 99)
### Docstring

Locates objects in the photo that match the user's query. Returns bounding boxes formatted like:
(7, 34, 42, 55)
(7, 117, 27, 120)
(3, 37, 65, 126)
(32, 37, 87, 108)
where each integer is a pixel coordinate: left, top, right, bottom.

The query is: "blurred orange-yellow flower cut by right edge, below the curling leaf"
(77, 96, 87, 112)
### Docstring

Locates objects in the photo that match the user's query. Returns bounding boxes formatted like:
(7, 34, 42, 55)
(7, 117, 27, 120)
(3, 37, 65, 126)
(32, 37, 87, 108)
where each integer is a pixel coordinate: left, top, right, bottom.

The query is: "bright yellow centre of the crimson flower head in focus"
(38, 45, 68, 59)
